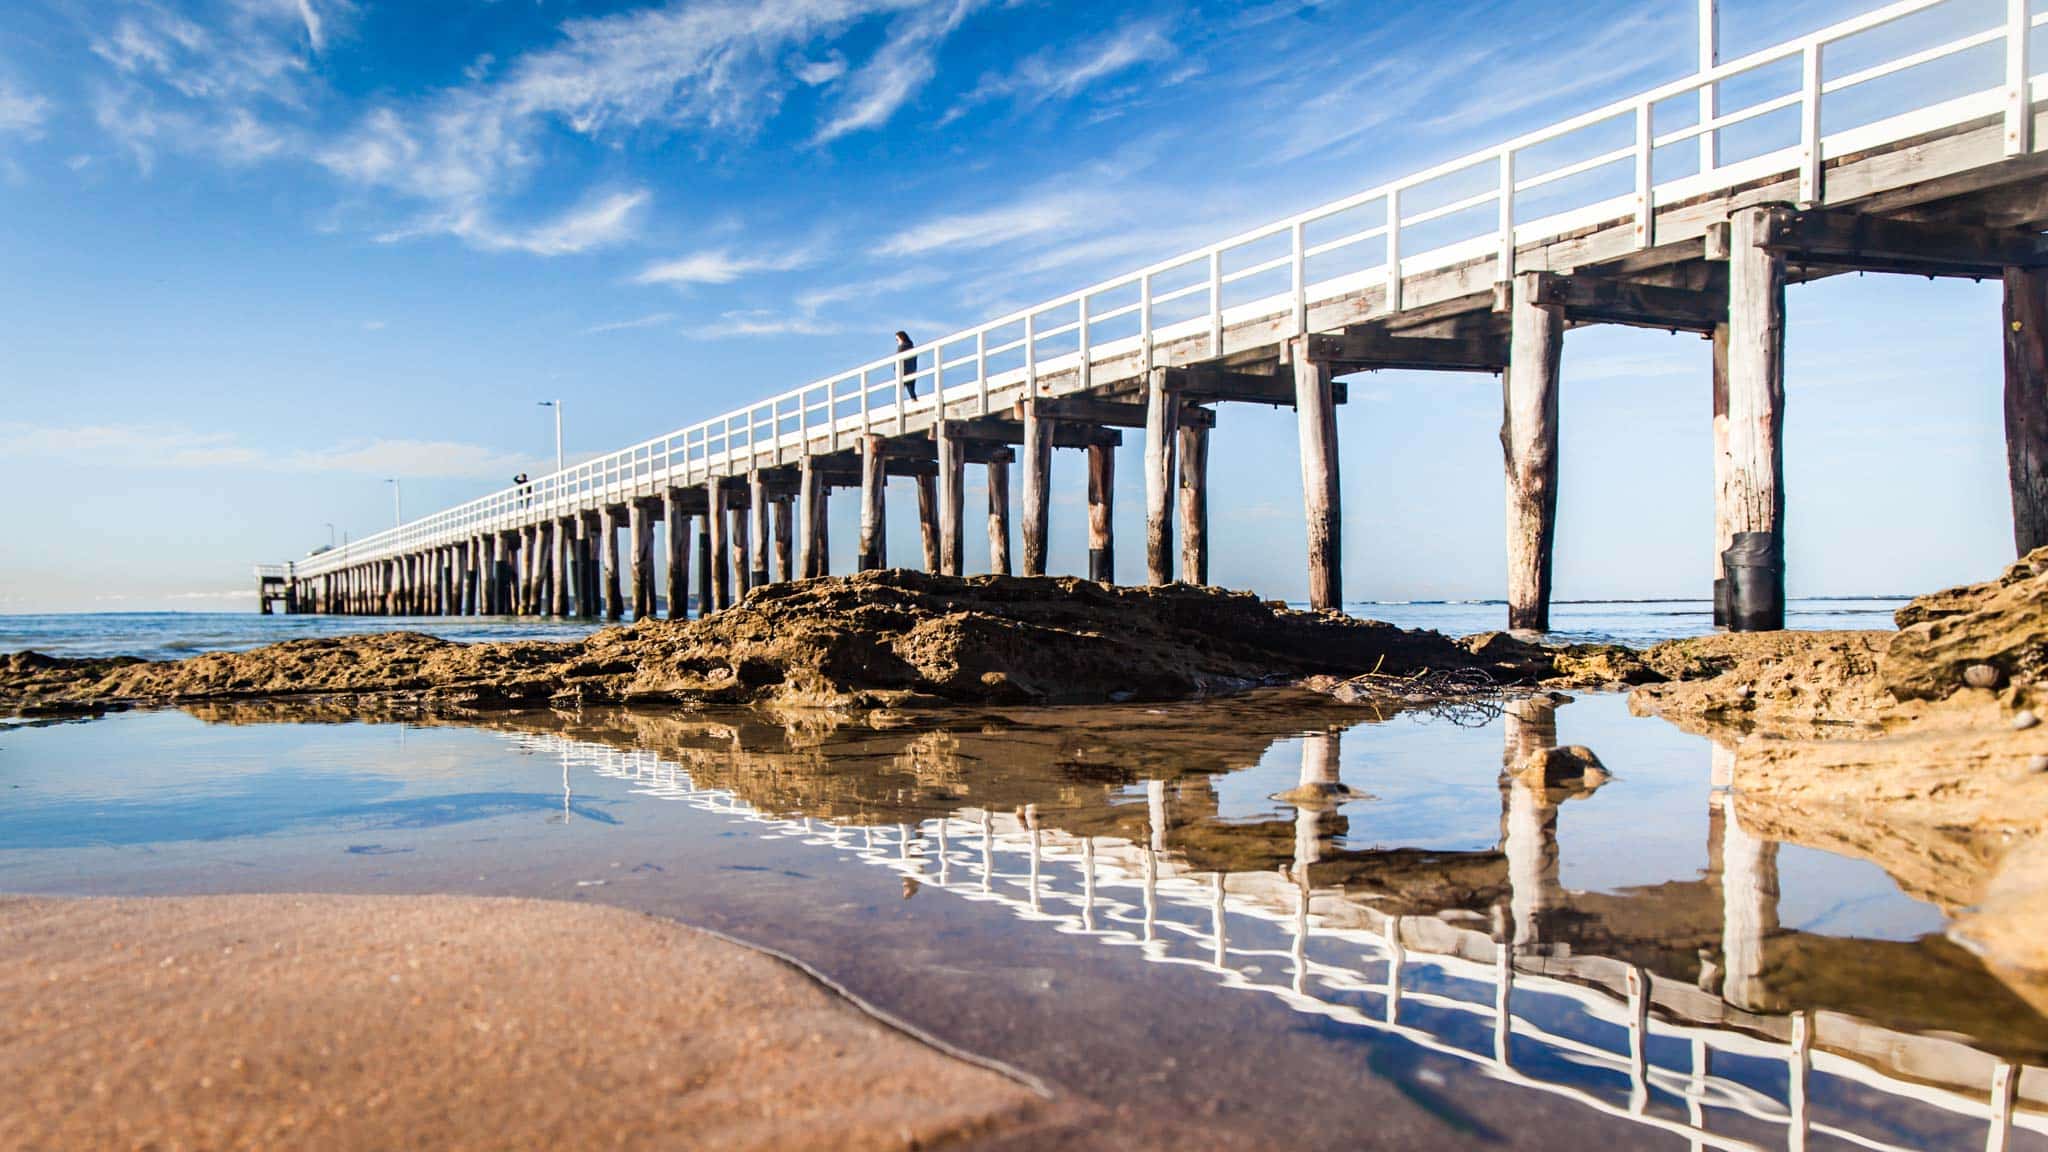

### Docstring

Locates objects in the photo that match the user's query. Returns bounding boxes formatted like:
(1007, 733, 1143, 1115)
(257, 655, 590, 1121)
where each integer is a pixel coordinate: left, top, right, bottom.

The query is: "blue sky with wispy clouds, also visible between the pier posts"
(0, 0, 2011, 613)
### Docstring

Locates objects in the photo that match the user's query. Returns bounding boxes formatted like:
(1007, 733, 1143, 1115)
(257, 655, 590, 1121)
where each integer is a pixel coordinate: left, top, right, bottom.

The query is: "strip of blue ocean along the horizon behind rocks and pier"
(0, 596, 1905, 660)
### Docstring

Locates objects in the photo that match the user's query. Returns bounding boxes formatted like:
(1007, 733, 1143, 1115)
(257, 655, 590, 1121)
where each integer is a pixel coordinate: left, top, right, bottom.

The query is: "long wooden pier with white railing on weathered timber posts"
(272, 0, 2048, 629)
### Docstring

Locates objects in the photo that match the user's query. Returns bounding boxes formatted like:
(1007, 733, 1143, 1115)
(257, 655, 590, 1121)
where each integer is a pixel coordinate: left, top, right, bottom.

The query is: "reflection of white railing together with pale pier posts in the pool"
(487, 725, 2048, 1150)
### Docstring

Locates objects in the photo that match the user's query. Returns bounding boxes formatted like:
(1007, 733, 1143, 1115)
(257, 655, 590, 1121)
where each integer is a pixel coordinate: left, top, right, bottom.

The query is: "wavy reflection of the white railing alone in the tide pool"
(508, 734, 2048, 1152)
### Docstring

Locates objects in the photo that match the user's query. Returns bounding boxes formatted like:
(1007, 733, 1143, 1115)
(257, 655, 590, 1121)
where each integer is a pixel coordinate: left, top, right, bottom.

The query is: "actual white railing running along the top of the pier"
(284, 0, 2048, 576)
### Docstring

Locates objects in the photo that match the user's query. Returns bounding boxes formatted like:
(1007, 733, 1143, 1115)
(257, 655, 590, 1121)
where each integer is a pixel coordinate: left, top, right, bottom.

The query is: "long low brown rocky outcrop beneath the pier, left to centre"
(0, 570, 1597, 711)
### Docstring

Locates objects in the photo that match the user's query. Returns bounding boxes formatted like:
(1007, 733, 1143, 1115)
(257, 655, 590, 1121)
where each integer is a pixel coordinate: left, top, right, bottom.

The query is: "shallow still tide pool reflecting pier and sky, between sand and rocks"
(0, 693, 2048, 1148)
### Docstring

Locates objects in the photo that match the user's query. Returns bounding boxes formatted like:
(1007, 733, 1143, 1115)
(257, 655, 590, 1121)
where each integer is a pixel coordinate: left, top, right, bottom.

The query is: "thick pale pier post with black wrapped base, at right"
(1718, 207, 1786, 631)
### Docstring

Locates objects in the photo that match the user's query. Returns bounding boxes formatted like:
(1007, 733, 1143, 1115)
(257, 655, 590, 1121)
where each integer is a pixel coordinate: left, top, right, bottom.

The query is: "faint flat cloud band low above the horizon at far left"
(0, 422, 532, 478)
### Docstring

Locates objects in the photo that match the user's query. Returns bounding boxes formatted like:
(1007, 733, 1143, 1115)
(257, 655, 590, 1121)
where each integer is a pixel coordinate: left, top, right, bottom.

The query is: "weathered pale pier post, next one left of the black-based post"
(1501, 273, 1565, 631)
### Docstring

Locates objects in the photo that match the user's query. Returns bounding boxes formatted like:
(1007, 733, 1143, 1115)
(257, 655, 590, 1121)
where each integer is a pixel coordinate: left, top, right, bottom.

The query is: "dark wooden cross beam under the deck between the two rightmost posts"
(1761, 209, 2048, 279)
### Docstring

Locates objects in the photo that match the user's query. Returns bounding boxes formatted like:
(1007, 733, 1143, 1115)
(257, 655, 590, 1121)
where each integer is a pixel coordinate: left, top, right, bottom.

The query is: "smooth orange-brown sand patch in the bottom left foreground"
(0, 896, 1063, 1150)
